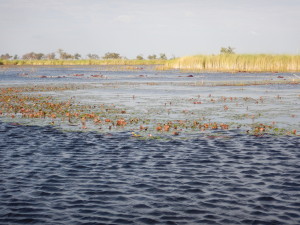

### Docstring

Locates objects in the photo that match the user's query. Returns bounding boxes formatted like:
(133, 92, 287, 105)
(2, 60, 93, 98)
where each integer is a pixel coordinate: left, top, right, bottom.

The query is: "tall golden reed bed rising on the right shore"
(160, 54, 300, 72)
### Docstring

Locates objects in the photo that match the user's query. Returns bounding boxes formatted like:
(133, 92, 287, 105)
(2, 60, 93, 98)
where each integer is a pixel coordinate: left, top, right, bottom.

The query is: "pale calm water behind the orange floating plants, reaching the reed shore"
(0, 66, 300, 132)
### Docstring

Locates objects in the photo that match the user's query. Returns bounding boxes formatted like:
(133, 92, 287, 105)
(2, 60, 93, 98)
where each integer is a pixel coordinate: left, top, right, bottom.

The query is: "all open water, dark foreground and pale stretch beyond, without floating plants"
(0, 67, 300, 225)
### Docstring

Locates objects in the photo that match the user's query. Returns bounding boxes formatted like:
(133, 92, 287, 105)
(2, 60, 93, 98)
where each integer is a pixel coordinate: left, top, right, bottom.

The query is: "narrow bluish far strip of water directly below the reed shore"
(0, 66, 295, 83)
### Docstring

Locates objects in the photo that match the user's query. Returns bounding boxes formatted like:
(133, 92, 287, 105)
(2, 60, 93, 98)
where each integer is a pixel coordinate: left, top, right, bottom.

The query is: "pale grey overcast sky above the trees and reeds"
(0, 0, 300, 58)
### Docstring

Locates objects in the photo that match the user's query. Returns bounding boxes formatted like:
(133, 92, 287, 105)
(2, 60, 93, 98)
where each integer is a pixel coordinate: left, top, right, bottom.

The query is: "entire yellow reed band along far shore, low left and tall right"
(0, 54, 300, 73)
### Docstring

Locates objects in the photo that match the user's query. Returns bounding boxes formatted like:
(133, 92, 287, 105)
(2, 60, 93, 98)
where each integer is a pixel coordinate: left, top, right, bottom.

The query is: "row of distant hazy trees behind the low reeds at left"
(0, 49, 171, 60)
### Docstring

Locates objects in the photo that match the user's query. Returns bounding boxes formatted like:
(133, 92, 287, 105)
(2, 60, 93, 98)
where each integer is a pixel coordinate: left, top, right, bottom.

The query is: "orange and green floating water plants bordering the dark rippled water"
(0, 84, 297, 139)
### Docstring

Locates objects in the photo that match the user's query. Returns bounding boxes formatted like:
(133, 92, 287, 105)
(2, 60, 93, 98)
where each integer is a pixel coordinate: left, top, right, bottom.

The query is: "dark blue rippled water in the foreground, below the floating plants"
(0, 123, 300, 224)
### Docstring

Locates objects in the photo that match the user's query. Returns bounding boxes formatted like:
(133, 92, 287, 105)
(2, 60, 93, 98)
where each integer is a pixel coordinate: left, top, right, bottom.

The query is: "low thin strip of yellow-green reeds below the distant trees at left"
(0, 59, 166, 66)
